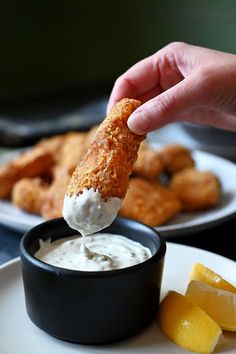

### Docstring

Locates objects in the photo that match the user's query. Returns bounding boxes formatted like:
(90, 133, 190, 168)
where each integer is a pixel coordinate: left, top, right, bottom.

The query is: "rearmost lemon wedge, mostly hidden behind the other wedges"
(190, 263, 236, 294)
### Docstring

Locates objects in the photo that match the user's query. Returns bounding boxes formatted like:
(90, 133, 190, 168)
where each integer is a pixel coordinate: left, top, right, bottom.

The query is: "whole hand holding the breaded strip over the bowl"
(107, 42, 236, 134)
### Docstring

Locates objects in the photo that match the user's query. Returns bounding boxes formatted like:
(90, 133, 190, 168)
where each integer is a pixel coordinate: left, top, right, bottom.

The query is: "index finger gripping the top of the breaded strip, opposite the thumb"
(107, 55, 159, 112)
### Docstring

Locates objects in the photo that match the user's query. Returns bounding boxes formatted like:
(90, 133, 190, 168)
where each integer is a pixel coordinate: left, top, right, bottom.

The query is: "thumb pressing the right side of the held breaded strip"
(127, 75, 207, 134)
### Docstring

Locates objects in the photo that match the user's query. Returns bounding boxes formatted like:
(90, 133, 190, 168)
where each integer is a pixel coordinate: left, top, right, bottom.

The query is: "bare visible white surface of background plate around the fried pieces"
(0, 151, 236, 238)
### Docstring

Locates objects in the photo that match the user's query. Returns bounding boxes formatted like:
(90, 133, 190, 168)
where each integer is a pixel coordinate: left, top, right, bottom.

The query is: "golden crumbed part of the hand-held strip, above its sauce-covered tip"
(66, 98, 145, 200)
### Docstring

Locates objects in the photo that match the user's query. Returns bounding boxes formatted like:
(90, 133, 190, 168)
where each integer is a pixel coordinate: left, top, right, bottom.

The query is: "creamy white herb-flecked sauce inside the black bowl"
(34, 233, 152, 271)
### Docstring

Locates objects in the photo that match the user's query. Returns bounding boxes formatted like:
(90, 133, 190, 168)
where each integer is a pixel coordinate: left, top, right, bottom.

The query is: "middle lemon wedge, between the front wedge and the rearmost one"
(185, 280, 236, 331)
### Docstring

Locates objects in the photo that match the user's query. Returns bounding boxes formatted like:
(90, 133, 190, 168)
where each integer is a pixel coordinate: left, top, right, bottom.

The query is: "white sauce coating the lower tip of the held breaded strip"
(62, 188, 122, 236)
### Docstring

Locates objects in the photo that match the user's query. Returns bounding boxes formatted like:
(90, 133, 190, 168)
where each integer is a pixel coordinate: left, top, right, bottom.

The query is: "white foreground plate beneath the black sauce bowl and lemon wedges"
(0, 243, 236, 354)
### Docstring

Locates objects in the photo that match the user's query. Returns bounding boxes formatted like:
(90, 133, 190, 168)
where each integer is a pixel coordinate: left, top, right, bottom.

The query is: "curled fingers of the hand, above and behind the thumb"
(107, 43, 187, 113)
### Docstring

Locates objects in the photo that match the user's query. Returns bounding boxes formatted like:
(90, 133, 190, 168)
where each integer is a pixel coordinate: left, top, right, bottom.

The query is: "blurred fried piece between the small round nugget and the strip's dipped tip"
(41, 174, 71, 219)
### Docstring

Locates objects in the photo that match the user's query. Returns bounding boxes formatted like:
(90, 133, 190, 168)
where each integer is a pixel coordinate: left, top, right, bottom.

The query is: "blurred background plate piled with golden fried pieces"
(0, 127, 236, 237)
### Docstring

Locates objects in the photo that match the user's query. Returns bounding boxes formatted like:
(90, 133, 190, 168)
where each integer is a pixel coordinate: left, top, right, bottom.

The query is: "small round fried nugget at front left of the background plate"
(12, 177, 49, 214)
